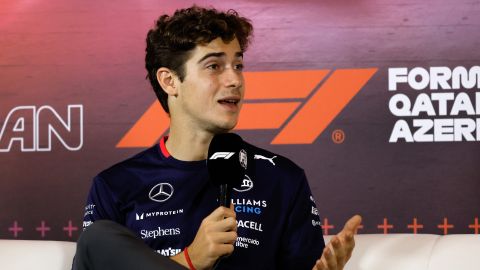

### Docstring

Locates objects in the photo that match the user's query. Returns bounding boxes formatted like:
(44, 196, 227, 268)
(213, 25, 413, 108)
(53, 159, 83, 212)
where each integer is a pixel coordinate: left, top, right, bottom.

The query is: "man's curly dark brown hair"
(145, 6, 253, 113)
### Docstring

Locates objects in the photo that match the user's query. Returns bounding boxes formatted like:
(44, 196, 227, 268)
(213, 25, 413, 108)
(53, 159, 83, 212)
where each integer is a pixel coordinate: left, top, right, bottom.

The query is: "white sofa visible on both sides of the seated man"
(0, 234, 480, 270)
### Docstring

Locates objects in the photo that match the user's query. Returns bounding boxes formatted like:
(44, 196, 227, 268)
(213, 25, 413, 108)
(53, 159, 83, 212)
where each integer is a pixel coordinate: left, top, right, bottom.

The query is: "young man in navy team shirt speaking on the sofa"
(77, 6, 360, 269)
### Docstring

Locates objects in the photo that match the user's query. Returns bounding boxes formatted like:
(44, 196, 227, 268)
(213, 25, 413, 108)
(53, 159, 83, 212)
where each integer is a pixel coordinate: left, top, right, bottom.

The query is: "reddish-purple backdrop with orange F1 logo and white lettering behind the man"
(0, 0, 480, 241)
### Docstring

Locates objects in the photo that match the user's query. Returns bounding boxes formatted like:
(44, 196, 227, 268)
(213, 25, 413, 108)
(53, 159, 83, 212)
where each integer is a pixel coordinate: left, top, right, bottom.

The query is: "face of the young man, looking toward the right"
(171, 38, 244, 133)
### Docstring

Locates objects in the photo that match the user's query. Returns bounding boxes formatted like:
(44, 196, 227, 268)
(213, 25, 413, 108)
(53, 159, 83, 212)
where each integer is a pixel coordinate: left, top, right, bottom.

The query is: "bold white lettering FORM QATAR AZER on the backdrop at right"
(388, 66, 480, 143)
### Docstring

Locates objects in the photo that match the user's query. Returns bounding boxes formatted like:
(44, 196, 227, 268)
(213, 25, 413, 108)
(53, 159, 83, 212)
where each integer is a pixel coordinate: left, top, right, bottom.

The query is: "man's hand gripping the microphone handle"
(172, 205, 237, 270)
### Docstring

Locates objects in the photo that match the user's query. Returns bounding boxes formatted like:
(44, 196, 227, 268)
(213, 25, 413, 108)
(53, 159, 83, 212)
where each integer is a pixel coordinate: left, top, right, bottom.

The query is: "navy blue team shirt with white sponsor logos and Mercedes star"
(83, 137, 325, 269)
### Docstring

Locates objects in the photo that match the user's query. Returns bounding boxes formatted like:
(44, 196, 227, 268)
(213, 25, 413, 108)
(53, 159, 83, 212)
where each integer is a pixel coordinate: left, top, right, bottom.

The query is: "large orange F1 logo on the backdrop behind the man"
(117, 68, 377, 148)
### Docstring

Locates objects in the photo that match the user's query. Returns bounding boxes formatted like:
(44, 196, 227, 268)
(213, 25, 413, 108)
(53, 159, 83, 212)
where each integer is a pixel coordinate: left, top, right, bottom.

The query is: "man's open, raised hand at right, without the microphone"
(313, 215, 362, 270)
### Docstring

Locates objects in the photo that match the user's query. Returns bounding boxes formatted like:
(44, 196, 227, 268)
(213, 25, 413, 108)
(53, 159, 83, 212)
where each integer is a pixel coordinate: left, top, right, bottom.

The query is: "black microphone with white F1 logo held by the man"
(207, 133, 248, 208)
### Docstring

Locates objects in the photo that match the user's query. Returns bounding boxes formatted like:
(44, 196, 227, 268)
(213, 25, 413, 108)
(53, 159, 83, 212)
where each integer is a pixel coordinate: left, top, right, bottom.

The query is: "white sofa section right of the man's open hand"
(325, 234, 480, 270)
